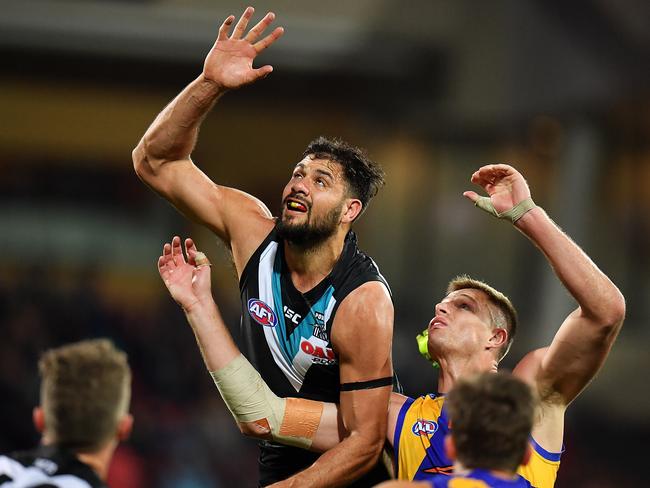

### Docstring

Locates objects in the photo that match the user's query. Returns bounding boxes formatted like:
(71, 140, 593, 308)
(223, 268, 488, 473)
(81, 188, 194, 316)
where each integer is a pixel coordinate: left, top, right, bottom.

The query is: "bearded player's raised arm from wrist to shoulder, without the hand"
(133, 75, 273, 273)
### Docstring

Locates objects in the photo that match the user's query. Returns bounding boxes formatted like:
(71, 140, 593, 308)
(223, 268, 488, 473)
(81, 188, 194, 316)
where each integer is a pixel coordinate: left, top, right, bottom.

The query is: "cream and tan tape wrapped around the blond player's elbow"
(210, 355, 323, 449)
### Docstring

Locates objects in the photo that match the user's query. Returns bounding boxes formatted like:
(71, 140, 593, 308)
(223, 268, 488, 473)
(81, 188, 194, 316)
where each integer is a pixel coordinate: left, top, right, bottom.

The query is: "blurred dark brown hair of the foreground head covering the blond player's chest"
(445, 373, 537, 471)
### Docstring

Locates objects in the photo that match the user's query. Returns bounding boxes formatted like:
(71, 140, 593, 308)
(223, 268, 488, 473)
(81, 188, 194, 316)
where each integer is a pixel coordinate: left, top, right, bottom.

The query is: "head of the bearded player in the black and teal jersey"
(278, 137, 384, 248)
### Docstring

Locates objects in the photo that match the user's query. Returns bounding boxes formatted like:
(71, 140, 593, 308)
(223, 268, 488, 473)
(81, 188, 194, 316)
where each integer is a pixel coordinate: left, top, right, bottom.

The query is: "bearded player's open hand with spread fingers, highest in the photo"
(203, 7, 284, 89)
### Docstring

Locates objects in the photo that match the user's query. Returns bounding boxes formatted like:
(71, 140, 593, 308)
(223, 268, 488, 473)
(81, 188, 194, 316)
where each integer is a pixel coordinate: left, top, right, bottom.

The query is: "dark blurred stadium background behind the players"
(0, 0, 650, 488)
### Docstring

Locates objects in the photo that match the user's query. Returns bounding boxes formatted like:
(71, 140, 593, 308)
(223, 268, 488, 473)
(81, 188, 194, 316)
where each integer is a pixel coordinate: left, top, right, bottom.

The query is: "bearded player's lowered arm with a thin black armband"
(272, 282, 393, 487)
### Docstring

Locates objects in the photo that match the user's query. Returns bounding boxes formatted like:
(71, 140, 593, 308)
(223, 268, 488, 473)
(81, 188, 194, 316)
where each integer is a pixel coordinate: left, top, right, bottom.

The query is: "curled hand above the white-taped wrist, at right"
(463, 164, 530, 214)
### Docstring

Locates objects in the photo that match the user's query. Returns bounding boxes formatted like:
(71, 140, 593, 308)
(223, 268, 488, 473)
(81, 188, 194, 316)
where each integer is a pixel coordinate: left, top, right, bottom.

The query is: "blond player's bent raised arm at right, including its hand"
(465, 164, 625, 406)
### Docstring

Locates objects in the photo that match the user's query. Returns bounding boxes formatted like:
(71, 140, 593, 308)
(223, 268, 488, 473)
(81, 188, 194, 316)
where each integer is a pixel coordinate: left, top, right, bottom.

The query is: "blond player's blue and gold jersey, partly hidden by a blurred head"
(393, 393, 560, 488)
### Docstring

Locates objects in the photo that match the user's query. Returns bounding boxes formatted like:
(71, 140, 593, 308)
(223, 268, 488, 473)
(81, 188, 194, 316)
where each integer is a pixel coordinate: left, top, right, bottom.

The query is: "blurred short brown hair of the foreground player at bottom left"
(38, 339, 131, 451)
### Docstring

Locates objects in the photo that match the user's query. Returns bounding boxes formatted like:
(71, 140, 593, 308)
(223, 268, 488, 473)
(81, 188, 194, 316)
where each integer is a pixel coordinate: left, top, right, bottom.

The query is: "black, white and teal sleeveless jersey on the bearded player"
(239, 229, 390, 486)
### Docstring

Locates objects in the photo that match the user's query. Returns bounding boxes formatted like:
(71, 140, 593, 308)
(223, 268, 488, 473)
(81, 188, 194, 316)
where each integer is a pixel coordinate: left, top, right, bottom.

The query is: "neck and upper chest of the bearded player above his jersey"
(284, 232, 347, 293)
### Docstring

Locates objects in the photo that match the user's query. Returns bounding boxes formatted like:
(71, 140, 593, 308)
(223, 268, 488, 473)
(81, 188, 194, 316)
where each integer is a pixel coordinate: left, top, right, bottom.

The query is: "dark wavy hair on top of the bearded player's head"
(302, 136, 385, 212)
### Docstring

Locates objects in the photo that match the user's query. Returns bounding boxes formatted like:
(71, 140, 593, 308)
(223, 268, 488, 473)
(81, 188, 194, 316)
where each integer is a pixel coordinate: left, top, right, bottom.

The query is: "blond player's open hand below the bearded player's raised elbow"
(158, 236, 212, 310)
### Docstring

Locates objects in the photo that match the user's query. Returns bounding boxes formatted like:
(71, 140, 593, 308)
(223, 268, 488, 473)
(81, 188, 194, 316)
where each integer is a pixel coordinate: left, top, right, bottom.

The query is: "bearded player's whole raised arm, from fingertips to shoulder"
(133, 7, 283, 273)
